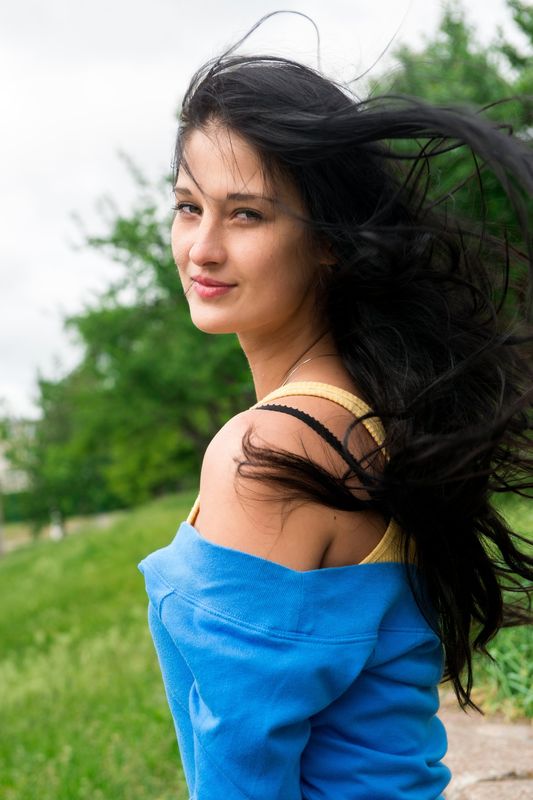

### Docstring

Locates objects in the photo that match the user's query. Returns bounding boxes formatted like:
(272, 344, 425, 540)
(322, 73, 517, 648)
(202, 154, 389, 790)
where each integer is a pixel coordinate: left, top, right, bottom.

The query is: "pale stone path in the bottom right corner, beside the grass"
(439, 702, 533, 800)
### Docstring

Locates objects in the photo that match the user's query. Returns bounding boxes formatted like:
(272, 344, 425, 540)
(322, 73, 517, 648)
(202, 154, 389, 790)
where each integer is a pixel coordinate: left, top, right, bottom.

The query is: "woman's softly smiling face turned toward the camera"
(172, 126, 317, 335)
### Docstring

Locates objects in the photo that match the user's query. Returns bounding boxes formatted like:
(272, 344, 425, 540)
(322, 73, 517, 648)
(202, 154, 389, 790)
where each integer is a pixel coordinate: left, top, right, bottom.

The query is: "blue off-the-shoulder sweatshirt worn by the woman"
(139, 382, 450, 800)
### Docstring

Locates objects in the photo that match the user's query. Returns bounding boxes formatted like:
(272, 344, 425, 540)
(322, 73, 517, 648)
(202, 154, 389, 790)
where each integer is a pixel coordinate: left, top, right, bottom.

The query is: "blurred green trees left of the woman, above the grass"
(17, 180, 254, 524)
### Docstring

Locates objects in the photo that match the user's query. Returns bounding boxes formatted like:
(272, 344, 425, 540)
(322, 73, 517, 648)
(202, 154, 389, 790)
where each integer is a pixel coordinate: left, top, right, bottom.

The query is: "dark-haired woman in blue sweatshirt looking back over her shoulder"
(139, 36, 533, 800)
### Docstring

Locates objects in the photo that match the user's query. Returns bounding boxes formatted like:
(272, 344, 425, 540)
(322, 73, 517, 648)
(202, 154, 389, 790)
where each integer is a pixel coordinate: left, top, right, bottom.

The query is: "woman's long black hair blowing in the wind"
(175, 43, 533, 707)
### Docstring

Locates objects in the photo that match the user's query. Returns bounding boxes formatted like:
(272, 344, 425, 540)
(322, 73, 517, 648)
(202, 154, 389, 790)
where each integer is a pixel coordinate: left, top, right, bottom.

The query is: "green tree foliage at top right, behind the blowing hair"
(372, 0, 533, 245)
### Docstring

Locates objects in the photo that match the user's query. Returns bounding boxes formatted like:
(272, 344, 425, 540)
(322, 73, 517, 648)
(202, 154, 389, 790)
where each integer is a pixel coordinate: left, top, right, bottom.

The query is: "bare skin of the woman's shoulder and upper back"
(195, 396, 385, 571)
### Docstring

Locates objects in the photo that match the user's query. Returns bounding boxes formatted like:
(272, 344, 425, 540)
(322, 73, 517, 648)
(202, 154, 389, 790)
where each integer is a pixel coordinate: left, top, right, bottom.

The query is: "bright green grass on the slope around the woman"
(0, 493, 533, 800)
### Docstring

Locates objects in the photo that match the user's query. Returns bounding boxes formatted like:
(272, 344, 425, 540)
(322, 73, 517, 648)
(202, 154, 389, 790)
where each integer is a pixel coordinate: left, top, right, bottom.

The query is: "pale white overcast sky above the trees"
(0, 0, 524, 416)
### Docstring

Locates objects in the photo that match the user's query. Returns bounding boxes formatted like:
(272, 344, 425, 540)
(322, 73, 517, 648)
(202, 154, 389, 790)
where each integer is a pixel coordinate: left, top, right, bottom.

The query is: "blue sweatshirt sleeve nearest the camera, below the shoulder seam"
(152, 594, 374, 800)
